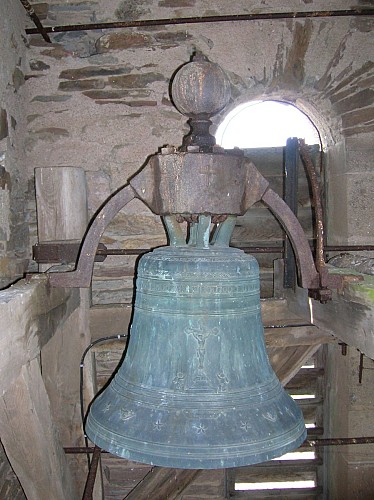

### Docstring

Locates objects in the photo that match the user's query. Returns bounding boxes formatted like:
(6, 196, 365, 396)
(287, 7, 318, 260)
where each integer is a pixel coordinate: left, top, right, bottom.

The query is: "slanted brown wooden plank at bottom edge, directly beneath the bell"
(126, 467, 200, 500)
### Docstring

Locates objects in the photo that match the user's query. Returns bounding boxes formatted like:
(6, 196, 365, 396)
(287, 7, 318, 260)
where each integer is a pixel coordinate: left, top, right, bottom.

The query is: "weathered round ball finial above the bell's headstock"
(171, 52, 231, 118)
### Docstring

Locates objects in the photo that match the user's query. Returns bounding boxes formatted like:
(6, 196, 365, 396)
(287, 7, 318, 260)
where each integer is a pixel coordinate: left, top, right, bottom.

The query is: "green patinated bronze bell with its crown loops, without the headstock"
(86, 216, 306, 469)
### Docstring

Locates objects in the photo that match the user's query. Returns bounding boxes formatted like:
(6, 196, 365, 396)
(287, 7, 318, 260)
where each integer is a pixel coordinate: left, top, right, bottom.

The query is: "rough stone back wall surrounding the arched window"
(21, 0, 373, 302)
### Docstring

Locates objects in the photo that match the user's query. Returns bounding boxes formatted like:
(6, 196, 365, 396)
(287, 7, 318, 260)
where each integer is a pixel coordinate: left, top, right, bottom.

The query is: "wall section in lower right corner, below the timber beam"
(324, 345, 374, 500)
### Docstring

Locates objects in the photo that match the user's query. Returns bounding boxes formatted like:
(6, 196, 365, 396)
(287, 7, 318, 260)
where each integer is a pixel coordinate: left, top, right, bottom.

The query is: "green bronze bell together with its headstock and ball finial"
(86, 57, 306, 469)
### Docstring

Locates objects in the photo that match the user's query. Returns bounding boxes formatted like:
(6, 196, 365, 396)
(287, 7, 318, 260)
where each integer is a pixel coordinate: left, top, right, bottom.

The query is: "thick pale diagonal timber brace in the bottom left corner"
(0, 359, 79, 500)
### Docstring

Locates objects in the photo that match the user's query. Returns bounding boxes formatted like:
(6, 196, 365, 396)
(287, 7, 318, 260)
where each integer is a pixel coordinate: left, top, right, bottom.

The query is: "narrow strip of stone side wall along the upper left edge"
(0, 0, 35, 288)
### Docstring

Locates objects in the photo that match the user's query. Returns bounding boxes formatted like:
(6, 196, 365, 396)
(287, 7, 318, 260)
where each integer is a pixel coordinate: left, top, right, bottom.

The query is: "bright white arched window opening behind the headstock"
(216, 101, 320, 149)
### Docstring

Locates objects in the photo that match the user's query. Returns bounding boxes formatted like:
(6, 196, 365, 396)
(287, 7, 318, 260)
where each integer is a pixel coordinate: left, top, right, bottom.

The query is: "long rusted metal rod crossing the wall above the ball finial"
(26, 8, 374, 35)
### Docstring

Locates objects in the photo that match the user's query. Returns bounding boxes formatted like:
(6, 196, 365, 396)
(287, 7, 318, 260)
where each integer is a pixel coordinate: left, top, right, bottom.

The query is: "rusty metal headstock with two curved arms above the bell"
(43, 148, 342, 302)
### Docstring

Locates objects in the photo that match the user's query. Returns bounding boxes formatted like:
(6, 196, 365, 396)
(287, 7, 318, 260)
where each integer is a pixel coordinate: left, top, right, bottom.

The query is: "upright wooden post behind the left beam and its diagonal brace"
(35, 167, 101, 498)
